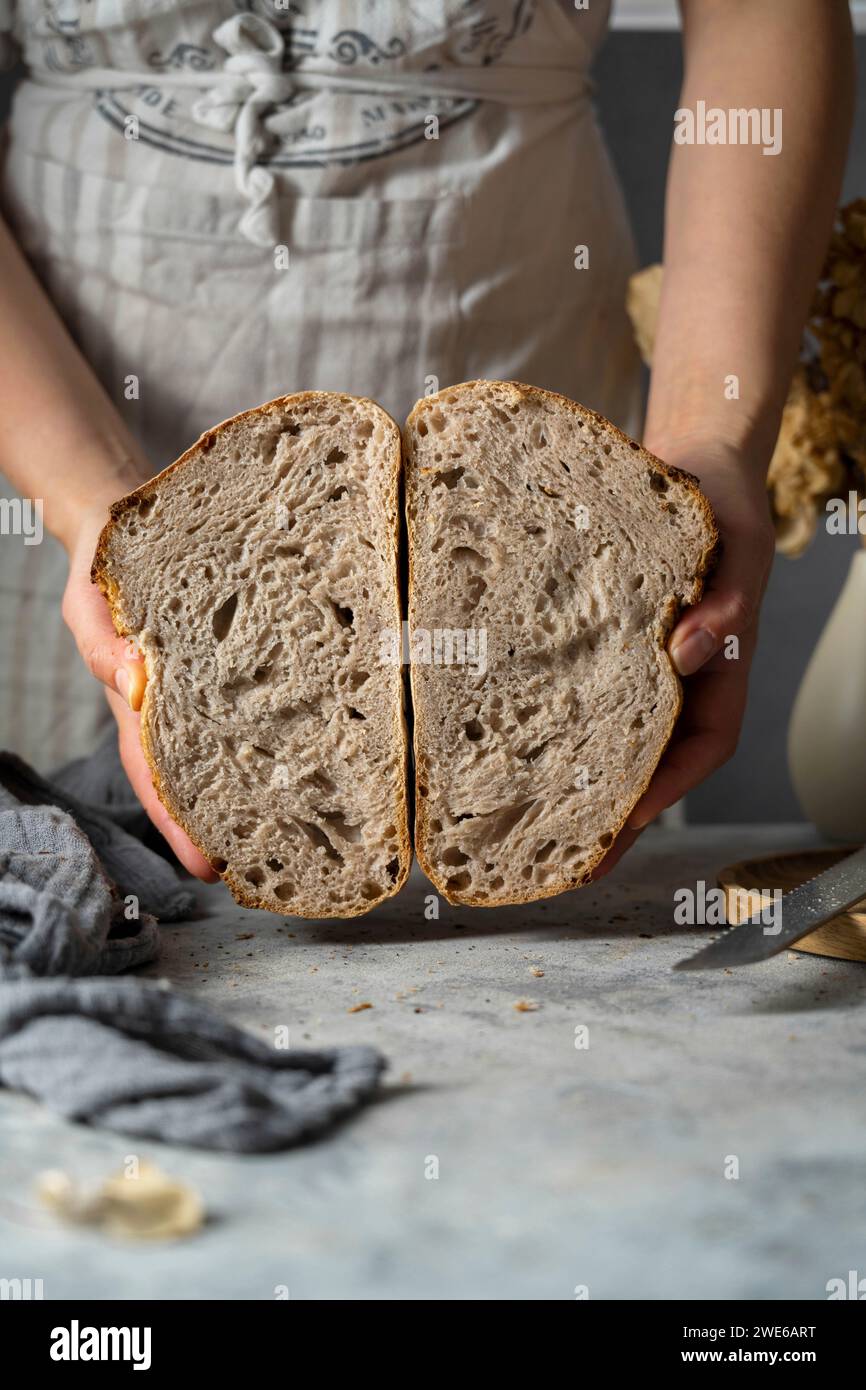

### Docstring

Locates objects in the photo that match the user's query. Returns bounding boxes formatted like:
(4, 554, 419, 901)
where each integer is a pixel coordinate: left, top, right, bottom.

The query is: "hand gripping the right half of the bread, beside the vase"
(592, 441, 774, 880)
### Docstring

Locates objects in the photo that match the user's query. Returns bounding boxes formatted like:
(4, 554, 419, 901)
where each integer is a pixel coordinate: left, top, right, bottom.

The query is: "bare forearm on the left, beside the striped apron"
(0, 211, 147, 549)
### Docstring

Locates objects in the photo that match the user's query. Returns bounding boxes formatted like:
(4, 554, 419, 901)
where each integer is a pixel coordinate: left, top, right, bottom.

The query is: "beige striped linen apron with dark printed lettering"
(0, 0, 639, 769)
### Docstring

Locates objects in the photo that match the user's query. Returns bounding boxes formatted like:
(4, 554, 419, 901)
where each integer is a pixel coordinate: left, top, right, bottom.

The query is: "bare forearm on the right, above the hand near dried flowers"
(645, 0, 853, 477)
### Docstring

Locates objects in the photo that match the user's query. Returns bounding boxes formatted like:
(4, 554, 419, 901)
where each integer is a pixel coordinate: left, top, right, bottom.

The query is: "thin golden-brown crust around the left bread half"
(90, 391, 411, 919)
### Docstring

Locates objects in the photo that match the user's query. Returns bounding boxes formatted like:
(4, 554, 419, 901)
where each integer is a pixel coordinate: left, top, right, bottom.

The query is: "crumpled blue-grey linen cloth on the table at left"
(0, 735, 385, 1152)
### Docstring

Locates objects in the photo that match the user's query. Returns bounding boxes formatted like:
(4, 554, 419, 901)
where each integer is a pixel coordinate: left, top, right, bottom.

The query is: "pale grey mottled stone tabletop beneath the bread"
(0, 826, 866, 1300)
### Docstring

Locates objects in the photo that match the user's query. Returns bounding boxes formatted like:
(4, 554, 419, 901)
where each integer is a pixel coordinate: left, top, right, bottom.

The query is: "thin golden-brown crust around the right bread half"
(403, 378, 721, 908)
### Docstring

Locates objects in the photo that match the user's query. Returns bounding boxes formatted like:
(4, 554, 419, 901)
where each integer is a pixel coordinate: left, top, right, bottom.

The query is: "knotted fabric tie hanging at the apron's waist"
(192, 14, 296, 246)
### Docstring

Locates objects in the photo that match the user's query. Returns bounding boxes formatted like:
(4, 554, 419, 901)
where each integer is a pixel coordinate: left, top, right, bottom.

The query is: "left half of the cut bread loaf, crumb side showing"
(93, 392, 411, 917)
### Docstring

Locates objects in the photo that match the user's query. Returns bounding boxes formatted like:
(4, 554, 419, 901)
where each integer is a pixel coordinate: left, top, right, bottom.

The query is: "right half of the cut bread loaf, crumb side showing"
(405, 381, 717, 906)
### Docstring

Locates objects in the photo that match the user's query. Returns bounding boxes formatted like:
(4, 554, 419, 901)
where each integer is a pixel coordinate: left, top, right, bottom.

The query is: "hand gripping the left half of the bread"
(63, 506, 217, 883)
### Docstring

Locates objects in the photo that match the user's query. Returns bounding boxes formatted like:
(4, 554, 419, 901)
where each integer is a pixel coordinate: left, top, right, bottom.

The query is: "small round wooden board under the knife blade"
(719, 845, 866, 960)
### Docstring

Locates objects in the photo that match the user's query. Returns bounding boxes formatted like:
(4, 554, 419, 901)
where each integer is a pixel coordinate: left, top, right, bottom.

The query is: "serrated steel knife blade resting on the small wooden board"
(674, 845, 866, 970)
